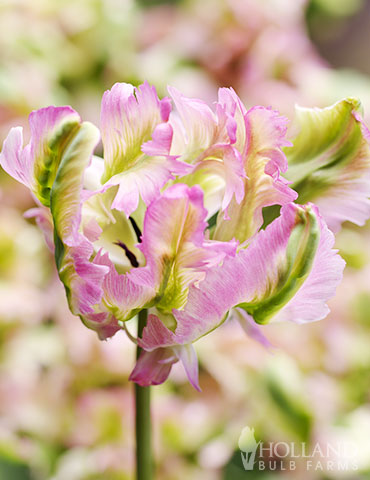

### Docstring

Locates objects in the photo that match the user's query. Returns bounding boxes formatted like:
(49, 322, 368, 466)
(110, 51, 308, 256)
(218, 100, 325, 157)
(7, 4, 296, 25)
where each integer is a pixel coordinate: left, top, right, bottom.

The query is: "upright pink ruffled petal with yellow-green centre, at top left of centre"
(101, 82, 187, 216)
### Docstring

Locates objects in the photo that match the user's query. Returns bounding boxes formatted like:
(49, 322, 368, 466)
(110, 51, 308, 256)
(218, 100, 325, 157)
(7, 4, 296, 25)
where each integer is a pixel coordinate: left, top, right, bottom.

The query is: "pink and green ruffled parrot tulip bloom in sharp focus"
(0, 83, 370, 388)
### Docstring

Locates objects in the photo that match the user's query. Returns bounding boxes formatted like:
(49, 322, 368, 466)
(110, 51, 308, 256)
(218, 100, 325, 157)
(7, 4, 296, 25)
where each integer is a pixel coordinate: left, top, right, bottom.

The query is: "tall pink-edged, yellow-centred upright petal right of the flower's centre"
(213, 102, 297, 243)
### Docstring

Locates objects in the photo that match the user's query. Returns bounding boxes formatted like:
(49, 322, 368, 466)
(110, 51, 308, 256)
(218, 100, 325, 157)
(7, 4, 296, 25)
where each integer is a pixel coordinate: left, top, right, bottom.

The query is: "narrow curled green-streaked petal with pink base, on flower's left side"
(51, 122, 108, 315)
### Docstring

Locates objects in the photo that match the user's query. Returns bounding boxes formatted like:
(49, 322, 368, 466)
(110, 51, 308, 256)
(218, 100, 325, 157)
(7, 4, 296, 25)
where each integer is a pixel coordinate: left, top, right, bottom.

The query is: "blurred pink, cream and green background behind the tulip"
(0, 0, 370, 480)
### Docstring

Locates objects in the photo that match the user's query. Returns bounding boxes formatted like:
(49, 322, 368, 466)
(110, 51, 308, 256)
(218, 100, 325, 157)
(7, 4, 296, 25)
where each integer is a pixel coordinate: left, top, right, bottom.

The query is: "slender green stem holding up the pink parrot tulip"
(135, 310, 153, 480)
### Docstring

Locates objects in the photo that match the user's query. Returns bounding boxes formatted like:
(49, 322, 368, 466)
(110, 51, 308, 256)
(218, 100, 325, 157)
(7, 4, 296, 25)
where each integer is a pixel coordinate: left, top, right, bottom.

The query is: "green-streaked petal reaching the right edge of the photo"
(286, 98, 370, 231)
